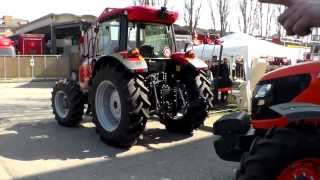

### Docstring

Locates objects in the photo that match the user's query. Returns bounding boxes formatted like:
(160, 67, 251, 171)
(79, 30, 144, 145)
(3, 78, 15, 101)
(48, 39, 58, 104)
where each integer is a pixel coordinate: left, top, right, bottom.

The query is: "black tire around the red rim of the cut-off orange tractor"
(236, 128, 320, 180)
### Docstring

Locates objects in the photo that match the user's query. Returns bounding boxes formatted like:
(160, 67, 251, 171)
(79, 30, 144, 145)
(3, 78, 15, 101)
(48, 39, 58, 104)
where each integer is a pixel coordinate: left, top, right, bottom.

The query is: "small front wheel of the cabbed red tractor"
(51, 79, 84, 127)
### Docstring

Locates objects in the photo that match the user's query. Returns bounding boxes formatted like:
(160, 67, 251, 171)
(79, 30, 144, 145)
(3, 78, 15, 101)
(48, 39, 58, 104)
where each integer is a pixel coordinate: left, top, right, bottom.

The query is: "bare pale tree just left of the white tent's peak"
(216, 0, 230, 36)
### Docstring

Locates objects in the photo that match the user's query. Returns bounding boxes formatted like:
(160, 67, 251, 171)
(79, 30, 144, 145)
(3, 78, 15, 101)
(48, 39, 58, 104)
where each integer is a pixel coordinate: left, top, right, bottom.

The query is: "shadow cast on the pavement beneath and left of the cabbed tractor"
(0, 119, 190, 161)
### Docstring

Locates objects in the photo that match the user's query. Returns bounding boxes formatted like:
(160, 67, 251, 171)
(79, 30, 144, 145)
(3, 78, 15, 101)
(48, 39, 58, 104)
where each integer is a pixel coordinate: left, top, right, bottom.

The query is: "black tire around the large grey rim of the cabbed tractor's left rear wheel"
(90, 64, 151, 148)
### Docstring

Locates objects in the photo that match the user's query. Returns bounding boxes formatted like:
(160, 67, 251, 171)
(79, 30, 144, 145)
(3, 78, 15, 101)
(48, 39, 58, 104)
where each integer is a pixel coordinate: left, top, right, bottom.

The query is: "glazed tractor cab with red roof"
(97, 6, 178, 58)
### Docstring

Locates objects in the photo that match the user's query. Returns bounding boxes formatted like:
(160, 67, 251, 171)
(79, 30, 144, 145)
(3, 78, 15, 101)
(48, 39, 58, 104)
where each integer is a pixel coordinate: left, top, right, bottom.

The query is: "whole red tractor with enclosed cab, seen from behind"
(52, 6, 212, 147)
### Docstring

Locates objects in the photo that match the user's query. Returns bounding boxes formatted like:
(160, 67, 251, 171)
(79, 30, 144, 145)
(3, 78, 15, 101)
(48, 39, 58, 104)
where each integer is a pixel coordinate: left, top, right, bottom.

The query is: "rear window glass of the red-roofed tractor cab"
(128, 23, 174, 58)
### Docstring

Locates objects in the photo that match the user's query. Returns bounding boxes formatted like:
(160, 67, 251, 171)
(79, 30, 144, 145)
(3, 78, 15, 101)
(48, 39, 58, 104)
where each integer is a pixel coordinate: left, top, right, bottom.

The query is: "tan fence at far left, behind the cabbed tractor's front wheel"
(0, 55, 70, 80)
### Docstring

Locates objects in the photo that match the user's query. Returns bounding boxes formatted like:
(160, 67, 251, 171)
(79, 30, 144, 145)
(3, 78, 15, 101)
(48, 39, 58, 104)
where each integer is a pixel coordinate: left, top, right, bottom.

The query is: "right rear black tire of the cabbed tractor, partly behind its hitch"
(164, 71, 213, 134)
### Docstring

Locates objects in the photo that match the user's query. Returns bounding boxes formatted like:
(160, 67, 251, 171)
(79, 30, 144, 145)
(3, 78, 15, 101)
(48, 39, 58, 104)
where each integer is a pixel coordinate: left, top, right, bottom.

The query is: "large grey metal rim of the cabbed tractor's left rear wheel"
(95, 81, 121, 132)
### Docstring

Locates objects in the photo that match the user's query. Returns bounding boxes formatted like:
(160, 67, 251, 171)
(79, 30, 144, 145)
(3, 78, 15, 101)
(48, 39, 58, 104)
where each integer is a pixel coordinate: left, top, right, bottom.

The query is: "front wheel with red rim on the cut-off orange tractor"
(236, 128, 320, 180)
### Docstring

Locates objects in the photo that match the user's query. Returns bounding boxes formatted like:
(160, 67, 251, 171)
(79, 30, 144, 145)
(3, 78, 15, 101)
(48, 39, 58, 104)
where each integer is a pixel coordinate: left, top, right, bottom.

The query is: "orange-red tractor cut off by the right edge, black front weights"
(213, 62, 320, 180)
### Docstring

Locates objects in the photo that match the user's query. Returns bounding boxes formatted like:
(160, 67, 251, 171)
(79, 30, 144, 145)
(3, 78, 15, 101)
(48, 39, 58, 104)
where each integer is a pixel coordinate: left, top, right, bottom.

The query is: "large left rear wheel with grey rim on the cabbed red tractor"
(90, 65, 151, 147)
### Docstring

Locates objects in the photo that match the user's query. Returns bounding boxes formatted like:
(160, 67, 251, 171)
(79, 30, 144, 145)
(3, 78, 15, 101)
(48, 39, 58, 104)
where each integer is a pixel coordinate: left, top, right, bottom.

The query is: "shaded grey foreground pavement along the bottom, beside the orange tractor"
(12, 138, 237, 180)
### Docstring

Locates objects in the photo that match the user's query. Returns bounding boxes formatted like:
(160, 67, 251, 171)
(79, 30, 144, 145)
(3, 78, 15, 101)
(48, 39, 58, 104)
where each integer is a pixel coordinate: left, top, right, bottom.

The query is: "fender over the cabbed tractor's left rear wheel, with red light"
(95, 54, 148, 73)
